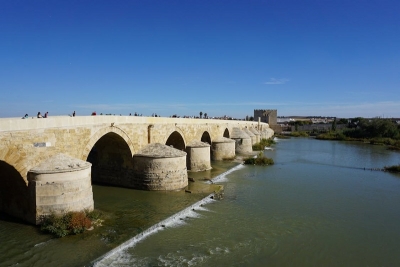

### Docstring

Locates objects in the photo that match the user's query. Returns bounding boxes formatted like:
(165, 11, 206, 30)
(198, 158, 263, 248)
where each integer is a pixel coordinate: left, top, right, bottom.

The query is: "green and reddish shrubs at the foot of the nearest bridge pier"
(40, 210, 102, 237)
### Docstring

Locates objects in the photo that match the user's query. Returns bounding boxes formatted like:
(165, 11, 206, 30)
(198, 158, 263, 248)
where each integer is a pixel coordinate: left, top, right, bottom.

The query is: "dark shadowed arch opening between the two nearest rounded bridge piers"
(86, 132, 133, 187)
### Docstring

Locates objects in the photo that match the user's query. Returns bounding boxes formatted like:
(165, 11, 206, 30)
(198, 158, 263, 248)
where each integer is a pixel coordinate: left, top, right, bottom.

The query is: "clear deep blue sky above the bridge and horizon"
(0, 0, 400, 118)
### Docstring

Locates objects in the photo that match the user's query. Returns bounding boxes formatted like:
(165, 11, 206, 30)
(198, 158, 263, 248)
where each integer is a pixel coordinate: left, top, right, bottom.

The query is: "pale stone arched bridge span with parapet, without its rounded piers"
(0, 115, 269, 224)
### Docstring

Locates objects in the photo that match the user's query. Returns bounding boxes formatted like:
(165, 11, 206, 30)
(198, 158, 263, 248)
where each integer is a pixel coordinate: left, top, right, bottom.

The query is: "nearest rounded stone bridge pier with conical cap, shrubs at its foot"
(28, 154, 94, 224)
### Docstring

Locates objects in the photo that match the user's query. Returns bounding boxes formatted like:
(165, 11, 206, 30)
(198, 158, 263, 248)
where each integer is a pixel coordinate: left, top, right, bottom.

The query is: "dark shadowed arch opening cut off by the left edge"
(0, 160, 32, 223)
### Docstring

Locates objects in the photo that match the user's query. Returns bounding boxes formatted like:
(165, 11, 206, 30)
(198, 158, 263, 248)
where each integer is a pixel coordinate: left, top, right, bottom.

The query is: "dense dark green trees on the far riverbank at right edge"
(316, 118, 400, 150)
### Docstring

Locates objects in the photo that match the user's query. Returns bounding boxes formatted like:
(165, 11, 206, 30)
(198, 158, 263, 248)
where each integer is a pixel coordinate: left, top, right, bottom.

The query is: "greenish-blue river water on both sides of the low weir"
(0, 138, 400, 266)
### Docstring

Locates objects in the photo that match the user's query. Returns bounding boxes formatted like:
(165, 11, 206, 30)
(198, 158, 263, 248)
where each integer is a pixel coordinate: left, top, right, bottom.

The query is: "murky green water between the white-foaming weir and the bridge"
(0, 162, 237, 267)
